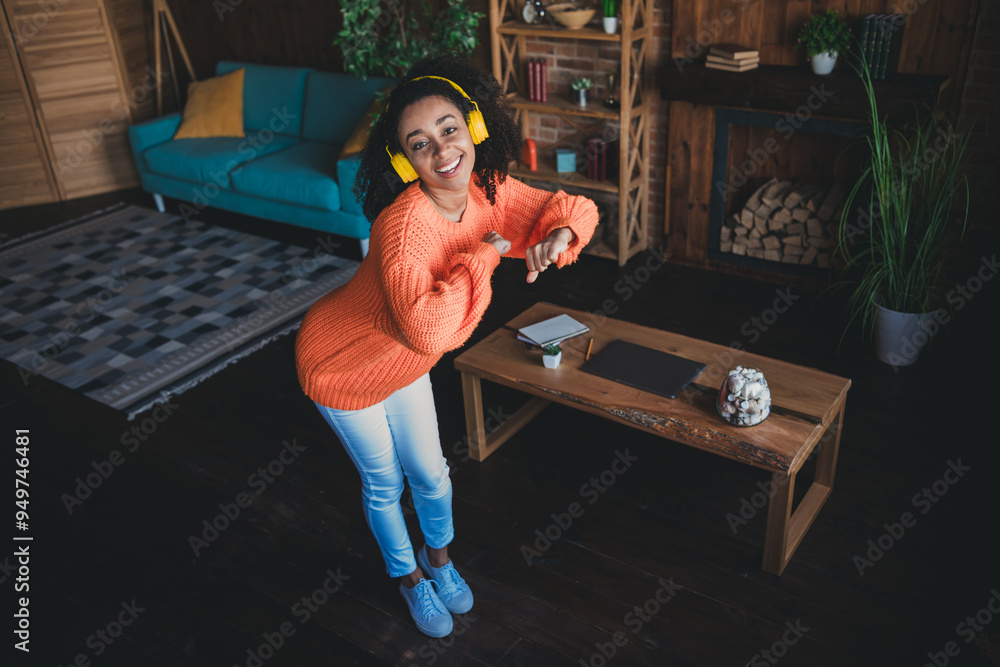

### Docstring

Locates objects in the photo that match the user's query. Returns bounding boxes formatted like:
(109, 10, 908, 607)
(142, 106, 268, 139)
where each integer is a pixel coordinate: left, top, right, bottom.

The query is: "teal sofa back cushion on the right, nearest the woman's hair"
(302, 72, 395, 144)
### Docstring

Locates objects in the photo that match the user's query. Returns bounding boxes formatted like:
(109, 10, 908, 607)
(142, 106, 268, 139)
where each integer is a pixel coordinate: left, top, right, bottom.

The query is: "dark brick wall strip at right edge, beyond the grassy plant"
(958, 0, 1000, 234)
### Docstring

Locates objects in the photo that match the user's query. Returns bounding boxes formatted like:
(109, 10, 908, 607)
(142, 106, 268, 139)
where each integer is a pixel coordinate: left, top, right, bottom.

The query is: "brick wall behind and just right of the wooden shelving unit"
(527, 0, 672, 248)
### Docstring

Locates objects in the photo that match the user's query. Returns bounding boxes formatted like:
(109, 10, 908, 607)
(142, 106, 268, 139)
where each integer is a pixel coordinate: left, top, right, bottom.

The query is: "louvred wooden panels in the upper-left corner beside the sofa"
(0, 0, 156, 208)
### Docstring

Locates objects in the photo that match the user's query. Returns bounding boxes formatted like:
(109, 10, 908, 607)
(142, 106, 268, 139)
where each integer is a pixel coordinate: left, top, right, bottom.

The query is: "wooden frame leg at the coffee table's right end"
(763, 405, 844, 575)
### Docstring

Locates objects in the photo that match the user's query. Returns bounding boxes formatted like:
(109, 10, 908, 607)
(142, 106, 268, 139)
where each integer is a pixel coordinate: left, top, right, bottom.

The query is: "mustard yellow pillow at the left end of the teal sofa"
(174, 69, 246, 139)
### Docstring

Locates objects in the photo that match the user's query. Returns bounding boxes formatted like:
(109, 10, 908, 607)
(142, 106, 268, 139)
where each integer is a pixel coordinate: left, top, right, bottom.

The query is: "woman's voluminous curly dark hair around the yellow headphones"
(354, 54, 521, 222)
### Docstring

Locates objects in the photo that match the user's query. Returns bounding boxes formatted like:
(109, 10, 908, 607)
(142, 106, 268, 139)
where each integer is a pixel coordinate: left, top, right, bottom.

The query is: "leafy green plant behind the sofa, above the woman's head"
(333, 0, 484, 77)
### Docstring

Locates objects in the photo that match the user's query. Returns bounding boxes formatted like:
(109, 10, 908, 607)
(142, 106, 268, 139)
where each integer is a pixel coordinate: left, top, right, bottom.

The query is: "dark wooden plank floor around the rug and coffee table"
(0, 191, 1000, 667)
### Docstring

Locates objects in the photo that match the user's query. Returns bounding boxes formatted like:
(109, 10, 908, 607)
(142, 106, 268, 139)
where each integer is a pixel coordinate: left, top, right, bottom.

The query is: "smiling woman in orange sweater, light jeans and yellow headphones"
(296, 57, 597, 637)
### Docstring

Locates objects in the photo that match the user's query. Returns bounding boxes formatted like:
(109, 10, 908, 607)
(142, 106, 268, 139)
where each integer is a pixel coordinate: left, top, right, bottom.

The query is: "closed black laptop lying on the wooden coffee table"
(580, 340, 705, 398)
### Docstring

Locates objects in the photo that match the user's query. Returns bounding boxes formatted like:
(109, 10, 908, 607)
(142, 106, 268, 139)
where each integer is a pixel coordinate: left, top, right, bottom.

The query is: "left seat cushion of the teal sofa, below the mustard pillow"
(142, 135, 299, 187)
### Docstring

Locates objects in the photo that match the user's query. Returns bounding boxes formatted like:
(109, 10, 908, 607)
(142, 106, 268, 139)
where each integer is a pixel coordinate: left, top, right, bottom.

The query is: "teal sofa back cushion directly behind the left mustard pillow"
(215, 60, 310, 137)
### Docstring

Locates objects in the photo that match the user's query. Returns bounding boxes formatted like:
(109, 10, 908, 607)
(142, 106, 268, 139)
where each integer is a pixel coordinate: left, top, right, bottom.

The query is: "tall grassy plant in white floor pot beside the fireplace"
(837, 62, 969, 366)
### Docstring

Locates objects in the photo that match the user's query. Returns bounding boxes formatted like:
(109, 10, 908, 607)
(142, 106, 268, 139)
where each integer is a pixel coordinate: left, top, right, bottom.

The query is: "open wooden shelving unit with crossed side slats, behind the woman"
(490, 0, 653, 265)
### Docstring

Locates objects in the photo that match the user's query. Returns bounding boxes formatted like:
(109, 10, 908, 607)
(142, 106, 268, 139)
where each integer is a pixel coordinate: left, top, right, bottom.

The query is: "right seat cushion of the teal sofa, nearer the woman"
(231, 141, 340, 211)
